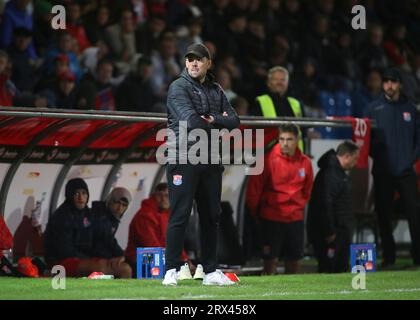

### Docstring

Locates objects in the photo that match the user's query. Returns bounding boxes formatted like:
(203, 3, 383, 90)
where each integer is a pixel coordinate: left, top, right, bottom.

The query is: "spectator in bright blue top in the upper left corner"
(0, 0, 38, 59)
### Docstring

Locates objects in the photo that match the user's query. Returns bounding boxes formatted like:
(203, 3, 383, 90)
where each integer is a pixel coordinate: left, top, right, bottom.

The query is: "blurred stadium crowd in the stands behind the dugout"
(0, 0, 420, 117)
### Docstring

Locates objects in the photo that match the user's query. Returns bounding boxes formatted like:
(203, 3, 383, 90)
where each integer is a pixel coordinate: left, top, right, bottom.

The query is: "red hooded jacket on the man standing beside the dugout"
(246, 144, 313, 223)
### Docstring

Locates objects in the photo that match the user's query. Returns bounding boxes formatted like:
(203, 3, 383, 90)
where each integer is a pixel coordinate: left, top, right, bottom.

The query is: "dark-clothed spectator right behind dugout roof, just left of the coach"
(116, 56, 158, 112)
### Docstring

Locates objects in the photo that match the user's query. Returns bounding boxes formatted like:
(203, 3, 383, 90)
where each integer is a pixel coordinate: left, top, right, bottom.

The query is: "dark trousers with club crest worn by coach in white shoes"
(165, 164, 224, 273)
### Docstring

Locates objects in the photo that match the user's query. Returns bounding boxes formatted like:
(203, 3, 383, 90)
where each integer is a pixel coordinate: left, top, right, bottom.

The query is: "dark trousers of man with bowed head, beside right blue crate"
(311, 230, 351, 273)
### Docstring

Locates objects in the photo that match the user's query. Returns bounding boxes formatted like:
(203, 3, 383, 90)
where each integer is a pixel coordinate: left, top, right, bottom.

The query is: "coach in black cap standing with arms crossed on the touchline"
(162, 44, 239, 285)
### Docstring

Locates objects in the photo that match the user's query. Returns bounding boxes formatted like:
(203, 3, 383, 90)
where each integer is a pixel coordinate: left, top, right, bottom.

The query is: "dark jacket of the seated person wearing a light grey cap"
(92, 201, 124, 259)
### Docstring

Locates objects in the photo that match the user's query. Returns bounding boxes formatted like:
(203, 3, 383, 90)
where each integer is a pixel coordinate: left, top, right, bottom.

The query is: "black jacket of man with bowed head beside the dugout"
(307, 149, 353, 242)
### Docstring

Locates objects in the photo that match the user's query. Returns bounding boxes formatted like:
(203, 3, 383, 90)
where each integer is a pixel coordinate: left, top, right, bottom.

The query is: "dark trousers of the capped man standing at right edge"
(374, 174, 420, 265)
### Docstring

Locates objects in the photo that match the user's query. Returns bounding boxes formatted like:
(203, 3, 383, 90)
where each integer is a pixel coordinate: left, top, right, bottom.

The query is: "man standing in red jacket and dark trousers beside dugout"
(246, 124, 313, 274)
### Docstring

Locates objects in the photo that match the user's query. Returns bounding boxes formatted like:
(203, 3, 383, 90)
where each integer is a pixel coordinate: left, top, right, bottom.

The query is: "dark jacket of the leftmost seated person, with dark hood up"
(45, 201, 93, 263)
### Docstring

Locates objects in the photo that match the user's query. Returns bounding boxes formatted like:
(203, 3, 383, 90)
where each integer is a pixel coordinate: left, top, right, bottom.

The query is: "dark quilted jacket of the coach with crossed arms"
(167, 69, 239, 161)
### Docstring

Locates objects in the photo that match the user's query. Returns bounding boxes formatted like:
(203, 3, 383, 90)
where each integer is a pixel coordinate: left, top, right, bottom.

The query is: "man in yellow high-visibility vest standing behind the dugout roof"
(251, 66, 304, 151)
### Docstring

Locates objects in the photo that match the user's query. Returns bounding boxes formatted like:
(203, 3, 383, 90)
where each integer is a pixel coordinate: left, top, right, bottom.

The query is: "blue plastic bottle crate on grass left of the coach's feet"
(137, 247, 165, 279)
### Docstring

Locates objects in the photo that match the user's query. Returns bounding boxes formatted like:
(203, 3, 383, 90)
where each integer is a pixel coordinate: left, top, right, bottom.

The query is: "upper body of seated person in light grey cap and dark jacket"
(92, 187, 131, 260)
